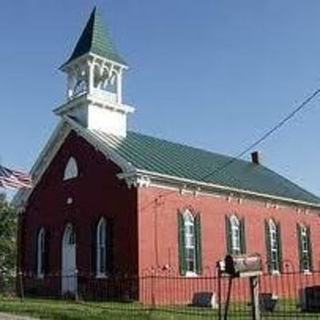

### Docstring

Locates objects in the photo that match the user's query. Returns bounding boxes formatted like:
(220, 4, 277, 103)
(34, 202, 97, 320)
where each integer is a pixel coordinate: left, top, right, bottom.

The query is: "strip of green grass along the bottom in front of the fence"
(0, 297, 320, 320)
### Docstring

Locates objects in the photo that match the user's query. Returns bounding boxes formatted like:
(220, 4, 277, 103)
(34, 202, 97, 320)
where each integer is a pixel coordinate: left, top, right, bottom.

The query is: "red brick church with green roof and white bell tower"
(14, 10, 320, 299)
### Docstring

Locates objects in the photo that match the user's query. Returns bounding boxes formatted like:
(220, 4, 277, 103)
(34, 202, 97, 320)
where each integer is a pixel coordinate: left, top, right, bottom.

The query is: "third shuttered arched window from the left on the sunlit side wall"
(266, 219, 282, 272)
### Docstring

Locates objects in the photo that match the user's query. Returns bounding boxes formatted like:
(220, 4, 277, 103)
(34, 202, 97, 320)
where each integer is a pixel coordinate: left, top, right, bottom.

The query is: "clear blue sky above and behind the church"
(0, 0, 320, 195)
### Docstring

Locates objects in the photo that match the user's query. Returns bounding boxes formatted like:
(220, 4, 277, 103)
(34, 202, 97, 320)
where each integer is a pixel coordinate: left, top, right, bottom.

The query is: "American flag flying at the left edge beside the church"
(0, 165, 32, 189)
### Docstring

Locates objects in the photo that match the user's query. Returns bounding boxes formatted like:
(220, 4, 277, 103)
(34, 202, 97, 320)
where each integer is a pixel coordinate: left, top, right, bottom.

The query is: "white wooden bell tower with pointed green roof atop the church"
(54, 8, 134, 136)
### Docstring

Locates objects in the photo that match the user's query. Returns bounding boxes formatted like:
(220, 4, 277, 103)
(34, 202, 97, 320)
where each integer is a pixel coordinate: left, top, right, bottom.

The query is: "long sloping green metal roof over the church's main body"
(93, 130, 320, 204)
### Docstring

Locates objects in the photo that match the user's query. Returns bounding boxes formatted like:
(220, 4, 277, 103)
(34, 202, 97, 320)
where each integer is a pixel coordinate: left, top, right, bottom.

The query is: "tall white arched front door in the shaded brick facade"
(61, 224, 78, 295)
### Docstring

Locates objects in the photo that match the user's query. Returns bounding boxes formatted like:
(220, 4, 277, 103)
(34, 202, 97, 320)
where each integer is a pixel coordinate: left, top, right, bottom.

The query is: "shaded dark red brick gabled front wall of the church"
(20, 132, 137, 296)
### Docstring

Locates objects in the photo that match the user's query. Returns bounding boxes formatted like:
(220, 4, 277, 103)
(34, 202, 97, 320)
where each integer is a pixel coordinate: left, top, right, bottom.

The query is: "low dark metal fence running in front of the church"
(2, 271, 320, 319)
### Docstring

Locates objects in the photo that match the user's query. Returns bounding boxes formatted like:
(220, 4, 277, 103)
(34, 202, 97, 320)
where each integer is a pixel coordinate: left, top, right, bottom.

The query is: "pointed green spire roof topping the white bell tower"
(64, 8, 126, 65)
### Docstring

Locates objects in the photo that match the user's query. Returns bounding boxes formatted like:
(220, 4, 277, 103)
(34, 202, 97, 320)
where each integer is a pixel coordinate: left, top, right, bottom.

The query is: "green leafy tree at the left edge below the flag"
(0, 194, 17, 290)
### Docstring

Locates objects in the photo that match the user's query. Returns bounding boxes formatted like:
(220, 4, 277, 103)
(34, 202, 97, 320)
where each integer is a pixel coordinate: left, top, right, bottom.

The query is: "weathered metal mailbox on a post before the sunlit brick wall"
(219, 253, 262, 277)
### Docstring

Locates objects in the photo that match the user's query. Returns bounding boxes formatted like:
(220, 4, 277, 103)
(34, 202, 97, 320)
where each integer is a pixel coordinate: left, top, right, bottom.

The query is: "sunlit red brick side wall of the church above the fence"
(138, 187, 320, 273)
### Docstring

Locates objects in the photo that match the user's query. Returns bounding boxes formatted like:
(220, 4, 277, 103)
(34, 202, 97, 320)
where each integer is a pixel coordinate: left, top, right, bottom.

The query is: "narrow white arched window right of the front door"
(96, 218, 107, 277)
